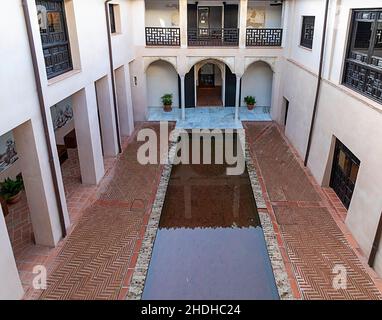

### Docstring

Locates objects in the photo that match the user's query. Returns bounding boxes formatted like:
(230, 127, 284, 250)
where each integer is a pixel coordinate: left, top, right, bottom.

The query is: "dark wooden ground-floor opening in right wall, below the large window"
(330, 140, 360, 208)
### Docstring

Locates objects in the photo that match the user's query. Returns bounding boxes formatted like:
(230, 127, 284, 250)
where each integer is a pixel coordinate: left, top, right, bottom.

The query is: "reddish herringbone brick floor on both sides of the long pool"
(20, 123, 382, 299)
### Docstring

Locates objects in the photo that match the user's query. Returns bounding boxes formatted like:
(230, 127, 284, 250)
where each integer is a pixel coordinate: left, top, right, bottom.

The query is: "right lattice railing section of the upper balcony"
(246, 28, 283, 47)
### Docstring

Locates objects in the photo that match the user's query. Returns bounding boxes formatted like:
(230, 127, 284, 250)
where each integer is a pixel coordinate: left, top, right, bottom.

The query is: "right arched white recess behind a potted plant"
(240, 61, 273, 113)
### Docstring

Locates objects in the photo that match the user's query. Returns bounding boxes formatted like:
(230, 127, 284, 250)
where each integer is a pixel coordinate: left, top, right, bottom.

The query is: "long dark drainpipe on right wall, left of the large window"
(304, 0, 330, 167)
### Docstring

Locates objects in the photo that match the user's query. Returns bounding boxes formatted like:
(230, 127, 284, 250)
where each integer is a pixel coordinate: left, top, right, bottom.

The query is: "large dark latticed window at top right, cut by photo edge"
(343, 9, 382, 102)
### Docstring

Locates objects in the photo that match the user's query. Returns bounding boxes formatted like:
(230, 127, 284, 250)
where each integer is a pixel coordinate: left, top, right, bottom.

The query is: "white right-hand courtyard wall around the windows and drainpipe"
(279, 0, 382, 275)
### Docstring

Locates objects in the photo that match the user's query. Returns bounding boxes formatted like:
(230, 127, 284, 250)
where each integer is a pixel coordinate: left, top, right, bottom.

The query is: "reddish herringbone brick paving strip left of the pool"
(36, 124, 172, 300)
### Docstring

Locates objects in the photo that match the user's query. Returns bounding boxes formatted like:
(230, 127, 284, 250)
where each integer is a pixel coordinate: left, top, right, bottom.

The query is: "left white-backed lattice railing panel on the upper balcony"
(146, 27, 180, 47)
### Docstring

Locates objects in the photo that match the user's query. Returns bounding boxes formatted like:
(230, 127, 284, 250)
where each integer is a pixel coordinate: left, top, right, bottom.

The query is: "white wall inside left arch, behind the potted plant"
(146, 61, 179, 108)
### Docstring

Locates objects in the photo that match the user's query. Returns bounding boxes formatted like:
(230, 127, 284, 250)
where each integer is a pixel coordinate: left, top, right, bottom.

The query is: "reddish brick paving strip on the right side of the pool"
(244, 122, 381, 299)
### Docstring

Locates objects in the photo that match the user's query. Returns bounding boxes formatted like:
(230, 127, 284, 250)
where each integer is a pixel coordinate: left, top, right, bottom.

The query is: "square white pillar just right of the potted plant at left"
(13, 119, 69, 247)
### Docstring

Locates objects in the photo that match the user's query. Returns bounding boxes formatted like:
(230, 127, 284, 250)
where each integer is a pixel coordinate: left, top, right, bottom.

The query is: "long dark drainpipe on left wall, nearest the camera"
(22, 0, 67, 238)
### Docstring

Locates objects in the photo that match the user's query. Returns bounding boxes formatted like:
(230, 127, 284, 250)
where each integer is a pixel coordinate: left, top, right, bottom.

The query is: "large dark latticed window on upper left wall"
(36, 0, 73, 79)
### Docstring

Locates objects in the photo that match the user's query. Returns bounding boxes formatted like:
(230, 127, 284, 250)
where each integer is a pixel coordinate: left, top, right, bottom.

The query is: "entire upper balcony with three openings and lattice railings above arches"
(145, 0, 283, 48)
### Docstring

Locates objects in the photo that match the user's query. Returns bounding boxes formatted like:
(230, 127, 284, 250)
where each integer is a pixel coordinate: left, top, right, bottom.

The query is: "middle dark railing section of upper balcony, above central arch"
(188, 28, 239, 47)
